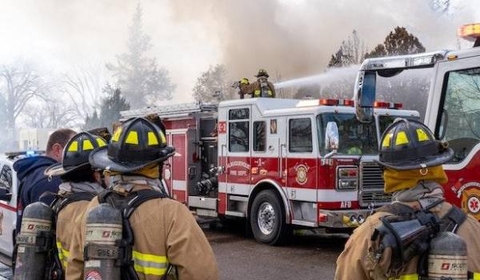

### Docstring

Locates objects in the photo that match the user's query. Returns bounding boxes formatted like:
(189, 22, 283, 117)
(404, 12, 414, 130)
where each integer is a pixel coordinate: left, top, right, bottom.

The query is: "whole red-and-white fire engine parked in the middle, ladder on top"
(121, 98, 419, 245)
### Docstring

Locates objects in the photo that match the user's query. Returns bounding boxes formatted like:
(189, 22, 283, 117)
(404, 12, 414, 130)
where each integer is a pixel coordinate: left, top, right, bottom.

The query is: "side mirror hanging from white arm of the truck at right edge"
(353, 71, 377, 123)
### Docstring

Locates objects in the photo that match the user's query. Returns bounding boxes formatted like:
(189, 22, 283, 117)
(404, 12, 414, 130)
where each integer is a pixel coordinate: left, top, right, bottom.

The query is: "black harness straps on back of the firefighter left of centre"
(85, 189, 169, 280)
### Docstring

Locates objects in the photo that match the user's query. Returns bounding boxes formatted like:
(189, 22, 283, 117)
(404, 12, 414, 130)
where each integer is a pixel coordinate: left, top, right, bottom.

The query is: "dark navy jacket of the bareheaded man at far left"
(13, 156, 61, 233)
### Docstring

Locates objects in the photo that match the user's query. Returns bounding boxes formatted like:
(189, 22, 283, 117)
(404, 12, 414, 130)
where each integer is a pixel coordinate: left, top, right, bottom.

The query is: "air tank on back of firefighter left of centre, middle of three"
(84, 203, 122, 280)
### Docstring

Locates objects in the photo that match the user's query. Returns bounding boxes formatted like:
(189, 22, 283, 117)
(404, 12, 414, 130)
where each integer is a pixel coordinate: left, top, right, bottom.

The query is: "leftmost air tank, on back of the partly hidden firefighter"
(14, 202, 54, 280)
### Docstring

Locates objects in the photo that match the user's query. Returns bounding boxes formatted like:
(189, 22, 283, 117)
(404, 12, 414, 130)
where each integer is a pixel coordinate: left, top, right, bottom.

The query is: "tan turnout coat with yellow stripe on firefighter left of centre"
(66, 185, 219, 280)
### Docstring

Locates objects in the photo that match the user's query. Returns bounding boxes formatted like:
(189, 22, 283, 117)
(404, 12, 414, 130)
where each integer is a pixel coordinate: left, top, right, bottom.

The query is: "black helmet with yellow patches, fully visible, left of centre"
(90, 118, 175, 173)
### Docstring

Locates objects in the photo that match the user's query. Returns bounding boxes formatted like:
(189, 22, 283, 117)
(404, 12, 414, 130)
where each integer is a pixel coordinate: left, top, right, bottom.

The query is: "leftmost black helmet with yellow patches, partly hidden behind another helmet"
(45, 132, 107, 176)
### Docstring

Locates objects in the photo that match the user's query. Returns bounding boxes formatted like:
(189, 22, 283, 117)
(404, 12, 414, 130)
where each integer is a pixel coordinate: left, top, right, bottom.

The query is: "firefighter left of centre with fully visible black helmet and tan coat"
(66, 118, 219, 279)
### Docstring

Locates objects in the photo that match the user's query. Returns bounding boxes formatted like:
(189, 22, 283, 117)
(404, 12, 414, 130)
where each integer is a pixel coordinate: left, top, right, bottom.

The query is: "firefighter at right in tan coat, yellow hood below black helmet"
(335, 119, 480, 280)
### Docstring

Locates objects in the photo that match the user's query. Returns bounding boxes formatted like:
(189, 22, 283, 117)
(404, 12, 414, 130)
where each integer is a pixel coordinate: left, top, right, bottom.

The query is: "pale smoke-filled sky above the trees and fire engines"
(0, 0, 480, 103)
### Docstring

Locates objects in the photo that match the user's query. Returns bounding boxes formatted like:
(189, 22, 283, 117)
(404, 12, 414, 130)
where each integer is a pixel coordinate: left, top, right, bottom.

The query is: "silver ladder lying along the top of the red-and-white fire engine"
(120, 102, 218, 121)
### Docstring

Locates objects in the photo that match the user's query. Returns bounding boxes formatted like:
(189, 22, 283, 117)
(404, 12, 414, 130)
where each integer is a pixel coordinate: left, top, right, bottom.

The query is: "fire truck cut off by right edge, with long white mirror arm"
(354, 23, 480, 220)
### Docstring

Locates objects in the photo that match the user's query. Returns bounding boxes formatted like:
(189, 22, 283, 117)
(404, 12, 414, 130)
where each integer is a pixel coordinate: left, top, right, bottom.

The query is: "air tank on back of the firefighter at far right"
(428, 232, 468, 280)
